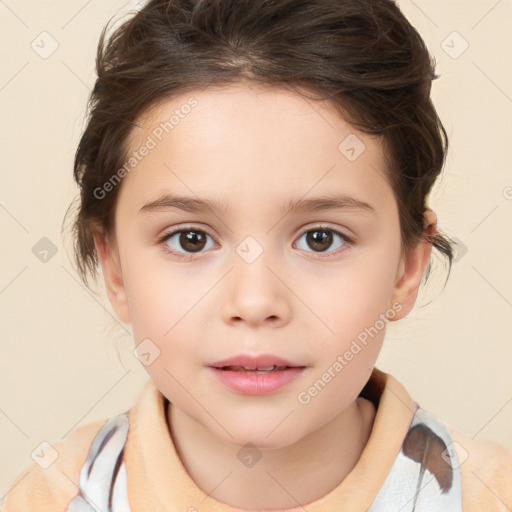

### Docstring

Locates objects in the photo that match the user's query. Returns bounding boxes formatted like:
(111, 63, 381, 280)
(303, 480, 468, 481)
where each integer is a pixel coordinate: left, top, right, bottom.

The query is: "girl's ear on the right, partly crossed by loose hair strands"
(390, 210, 437, 321)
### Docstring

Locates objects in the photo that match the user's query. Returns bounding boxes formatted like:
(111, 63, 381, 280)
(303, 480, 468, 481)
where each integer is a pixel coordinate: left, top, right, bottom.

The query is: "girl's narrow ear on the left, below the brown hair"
(93, 227, 130, 324)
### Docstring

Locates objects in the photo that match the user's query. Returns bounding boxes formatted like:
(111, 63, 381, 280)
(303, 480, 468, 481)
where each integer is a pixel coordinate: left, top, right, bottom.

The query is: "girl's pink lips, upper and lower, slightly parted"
(210, 354, 306, 396)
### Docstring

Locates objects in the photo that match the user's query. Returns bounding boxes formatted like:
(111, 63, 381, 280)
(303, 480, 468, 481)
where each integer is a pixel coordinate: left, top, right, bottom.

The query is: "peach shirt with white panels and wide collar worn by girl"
(0, 368, 512, 512)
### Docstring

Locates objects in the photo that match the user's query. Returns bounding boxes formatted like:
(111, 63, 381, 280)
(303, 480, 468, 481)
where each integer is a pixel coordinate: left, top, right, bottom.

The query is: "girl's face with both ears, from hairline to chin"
(96, 84, 430, 448)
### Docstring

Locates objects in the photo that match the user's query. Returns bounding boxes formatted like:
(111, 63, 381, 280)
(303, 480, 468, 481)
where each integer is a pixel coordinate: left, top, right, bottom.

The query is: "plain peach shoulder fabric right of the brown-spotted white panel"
(444, 422, 512, 512)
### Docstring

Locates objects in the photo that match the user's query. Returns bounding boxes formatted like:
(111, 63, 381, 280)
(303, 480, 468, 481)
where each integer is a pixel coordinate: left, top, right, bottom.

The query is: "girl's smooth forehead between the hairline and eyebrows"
(122, 84, 392, 216)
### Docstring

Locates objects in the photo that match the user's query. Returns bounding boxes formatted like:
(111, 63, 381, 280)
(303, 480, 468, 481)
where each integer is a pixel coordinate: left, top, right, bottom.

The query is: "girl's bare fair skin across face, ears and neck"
(95, 83, 436, 510)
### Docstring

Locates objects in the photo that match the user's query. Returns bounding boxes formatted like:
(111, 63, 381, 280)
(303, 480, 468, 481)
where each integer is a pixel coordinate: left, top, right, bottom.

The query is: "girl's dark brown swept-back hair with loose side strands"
(66, 0, 453, 292)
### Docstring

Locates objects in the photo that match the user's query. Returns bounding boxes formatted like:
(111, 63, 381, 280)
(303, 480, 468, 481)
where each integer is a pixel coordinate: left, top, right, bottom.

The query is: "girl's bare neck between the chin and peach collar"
(167, 398, 375, 510)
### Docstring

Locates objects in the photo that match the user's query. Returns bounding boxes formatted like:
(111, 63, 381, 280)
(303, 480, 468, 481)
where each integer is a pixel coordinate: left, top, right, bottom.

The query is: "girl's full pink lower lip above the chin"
(210, 367, 305, 396)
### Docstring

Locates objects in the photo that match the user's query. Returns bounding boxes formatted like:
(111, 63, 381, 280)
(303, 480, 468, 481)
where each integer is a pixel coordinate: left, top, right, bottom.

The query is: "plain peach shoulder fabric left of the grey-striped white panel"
(1, 418, 109, 512)
